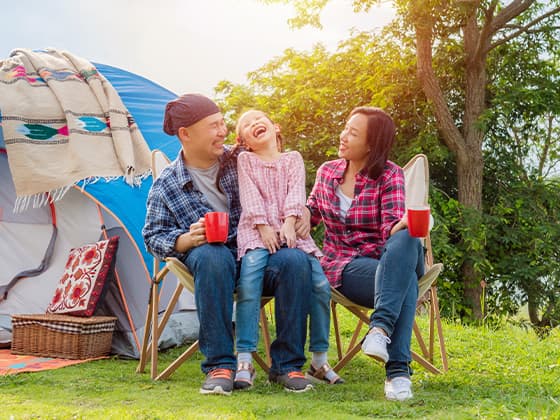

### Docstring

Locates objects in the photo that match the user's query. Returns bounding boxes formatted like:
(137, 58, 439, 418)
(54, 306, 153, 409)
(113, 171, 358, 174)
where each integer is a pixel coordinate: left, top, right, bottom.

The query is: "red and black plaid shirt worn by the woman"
(307, 159, 405, 287)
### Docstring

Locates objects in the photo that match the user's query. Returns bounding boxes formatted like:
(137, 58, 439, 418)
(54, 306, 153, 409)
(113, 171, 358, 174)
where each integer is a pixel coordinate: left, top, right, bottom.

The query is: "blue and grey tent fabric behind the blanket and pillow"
(0, 63, 198, 358)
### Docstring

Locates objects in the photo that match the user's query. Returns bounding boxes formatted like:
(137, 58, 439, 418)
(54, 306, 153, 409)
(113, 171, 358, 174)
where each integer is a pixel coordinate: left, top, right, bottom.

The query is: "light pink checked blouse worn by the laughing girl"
(237, 152, 322, 258)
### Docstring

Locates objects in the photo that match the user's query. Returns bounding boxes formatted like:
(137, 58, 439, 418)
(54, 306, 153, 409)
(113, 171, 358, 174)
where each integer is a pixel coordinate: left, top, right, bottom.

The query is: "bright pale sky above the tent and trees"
(0, 0, 394, 97)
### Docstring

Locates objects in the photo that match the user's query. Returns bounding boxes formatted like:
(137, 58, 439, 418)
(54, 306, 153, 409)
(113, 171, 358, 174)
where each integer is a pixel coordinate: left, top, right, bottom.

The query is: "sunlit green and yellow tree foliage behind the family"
(216, 1, 560, 334)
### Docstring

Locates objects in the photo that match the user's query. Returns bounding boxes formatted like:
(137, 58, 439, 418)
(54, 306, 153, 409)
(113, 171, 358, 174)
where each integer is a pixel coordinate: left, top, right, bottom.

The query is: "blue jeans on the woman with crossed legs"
(338, 230, 424, 379)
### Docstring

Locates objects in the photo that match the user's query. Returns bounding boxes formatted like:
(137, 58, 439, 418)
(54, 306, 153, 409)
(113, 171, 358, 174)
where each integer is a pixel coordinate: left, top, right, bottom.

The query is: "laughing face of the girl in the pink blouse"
(237, 110, 279, 151)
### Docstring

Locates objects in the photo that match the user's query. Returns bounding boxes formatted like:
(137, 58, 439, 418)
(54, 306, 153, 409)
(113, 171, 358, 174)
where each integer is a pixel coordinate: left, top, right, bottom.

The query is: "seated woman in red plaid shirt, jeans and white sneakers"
(307, 107, 424, 401)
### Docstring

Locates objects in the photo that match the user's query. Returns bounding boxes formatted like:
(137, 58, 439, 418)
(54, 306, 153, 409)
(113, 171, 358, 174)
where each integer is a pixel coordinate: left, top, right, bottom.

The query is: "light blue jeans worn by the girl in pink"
(235, 248, 331, 353)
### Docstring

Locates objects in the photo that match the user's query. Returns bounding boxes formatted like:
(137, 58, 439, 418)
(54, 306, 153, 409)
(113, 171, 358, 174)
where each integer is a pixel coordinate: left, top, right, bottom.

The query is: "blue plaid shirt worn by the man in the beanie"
(142, 146, 241, 260)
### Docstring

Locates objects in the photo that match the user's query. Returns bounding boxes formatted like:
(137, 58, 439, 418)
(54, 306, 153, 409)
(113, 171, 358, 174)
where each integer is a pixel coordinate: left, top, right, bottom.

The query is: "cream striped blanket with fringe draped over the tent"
(0, 49, 150, 211)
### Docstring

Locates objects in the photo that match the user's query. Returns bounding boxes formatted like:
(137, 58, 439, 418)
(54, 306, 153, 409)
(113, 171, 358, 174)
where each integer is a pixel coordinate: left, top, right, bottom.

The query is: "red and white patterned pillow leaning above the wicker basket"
(47, 236, 119, 316)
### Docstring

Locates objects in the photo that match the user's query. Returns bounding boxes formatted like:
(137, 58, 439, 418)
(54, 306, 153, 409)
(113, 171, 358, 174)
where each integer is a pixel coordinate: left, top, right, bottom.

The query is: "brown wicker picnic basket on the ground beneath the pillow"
(12, 314, 117, 359)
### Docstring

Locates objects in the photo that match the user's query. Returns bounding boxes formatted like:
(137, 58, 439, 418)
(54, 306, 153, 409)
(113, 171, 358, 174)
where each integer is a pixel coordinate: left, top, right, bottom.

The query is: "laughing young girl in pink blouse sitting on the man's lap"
(234, 110, 343, 389)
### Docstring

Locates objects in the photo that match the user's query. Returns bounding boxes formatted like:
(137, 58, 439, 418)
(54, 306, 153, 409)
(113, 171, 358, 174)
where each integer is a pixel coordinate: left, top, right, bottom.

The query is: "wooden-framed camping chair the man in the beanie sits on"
(136, 150, 272, 380)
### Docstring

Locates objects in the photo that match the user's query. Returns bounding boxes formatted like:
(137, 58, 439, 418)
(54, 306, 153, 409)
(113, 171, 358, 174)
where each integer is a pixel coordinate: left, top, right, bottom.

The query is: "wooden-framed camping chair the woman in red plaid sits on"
(331, 154, 448, 374)
